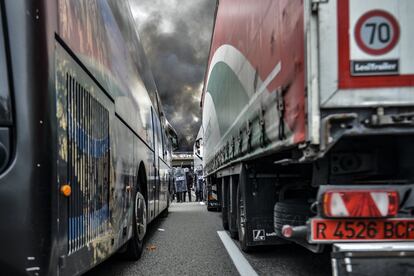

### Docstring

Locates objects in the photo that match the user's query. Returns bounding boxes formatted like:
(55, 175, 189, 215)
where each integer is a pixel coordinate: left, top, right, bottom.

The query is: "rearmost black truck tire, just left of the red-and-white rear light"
(274, 200, 312, 237)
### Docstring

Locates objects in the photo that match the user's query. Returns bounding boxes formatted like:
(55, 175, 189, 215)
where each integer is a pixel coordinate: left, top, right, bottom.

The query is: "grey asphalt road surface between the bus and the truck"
(86, 203, 330, 276)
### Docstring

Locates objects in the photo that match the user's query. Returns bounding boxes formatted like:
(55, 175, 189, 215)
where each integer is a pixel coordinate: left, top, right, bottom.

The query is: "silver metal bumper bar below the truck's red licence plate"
(331, 242, 414, 276)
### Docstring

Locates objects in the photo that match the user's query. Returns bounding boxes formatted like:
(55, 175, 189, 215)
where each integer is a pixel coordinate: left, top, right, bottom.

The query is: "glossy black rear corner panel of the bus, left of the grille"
(0, 1, 57, 275)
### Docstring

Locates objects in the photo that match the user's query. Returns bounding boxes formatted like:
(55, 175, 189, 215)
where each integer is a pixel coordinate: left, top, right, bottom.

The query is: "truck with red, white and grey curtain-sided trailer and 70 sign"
(201, 0, 414, 275)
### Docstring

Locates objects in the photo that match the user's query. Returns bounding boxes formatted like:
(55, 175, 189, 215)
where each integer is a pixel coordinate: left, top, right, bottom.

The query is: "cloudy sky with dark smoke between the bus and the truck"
(131, 0, 216, 151)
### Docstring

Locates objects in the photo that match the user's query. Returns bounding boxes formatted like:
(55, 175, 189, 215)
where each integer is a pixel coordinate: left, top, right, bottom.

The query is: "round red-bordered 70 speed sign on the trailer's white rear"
(355, 10, 400, 55)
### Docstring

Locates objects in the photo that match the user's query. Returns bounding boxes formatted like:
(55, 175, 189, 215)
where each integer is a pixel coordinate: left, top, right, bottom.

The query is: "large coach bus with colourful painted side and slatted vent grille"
(0, 0, 177, 275)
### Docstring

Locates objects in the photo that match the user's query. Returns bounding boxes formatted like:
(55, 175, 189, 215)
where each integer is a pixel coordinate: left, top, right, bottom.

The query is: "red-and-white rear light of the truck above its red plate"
(323, 190, 399, 218)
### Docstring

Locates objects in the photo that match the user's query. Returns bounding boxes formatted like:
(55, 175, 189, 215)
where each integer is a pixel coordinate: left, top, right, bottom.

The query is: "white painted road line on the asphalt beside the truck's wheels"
(217, 231, 258, 276)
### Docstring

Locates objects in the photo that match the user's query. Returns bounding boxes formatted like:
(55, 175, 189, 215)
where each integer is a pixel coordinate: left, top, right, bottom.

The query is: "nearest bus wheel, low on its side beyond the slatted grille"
(125, 191, 147, 261)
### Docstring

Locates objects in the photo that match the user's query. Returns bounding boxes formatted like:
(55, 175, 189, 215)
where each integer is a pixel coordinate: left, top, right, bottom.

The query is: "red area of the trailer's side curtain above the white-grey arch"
(203, 0, 306, 143)
